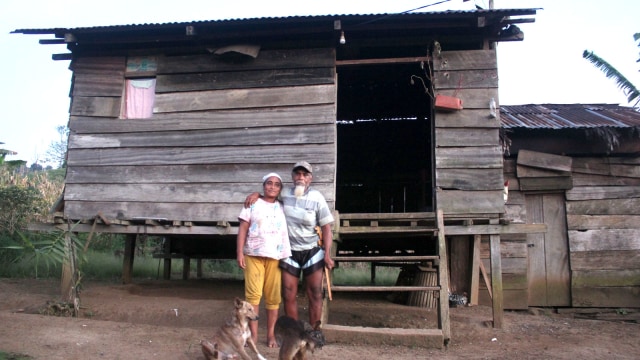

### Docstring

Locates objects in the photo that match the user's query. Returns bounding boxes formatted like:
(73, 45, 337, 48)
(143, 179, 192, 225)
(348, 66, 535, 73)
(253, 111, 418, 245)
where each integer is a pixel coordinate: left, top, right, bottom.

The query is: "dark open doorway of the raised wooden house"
(336, 63, 433, 213)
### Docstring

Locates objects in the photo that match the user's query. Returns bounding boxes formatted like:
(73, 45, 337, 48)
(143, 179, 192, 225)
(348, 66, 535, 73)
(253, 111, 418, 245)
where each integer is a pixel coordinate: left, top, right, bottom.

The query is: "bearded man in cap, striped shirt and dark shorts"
(245, 161, 334, 324)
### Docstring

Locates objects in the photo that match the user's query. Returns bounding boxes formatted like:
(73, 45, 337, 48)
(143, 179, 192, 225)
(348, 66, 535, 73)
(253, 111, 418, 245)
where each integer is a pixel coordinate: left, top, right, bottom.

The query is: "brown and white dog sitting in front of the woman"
(200, 298, 266, 360)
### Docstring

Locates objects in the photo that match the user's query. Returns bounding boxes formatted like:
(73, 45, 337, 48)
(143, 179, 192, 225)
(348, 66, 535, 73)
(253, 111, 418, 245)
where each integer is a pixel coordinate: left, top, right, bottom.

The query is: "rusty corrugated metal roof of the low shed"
(500, 104, 640, 129)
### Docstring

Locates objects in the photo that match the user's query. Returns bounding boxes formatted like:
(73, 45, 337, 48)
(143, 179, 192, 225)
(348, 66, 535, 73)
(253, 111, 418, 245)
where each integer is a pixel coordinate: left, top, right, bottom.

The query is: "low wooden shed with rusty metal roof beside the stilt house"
(501, 104, 640, 309)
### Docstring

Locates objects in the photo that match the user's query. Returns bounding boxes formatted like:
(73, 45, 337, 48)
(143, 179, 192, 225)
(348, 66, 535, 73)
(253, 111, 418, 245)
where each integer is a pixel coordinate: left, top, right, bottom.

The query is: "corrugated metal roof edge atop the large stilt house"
(12, 8, 540, 35)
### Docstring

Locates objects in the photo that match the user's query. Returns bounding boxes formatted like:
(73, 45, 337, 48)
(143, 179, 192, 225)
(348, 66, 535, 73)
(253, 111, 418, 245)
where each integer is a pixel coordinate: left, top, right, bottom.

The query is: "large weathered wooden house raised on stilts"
(15, 9, 544, 343)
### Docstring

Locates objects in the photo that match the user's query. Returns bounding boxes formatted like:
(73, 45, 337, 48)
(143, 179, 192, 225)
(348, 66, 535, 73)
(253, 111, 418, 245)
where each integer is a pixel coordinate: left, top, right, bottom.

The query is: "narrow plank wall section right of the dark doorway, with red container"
(433, 50, 504, 216)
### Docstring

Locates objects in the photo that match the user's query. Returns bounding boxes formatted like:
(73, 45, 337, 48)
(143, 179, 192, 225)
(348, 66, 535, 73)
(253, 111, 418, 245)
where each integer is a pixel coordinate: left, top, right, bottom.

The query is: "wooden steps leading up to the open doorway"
(323, 211, 451, 347)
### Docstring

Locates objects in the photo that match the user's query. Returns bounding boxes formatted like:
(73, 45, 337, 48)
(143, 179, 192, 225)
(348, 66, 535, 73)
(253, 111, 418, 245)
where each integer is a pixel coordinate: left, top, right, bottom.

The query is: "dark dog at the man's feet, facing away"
(275, 316, 325, 360)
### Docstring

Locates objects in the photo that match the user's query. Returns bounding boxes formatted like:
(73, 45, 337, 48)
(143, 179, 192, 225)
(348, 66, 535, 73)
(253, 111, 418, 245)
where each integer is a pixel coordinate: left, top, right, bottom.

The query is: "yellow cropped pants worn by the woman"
(244, 255, 282, 310)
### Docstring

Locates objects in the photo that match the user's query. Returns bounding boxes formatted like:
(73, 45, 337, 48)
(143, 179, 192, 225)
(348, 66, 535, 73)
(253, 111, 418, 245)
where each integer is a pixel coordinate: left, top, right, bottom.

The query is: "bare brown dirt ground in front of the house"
(0, 279, 640, 360)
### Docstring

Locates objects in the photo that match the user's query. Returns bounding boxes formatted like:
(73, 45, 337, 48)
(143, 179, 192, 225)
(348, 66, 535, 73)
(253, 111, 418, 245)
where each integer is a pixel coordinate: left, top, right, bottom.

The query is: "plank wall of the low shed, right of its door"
(566, 157, 640, 307)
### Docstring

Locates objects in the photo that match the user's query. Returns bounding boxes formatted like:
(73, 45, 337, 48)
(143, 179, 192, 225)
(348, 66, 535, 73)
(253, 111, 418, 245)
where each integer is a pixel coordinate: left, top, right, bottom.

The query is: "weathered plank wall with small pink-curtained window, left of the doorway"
(64, 49, 336, 222)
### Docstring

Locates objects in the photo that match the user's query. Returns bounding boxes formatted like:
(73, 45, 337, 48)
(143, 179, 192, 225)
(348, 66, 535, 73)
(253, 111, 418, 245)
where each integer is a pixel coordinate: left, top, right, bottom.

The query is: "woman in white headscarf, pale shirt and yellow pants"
(236, 173, 291, 347)
